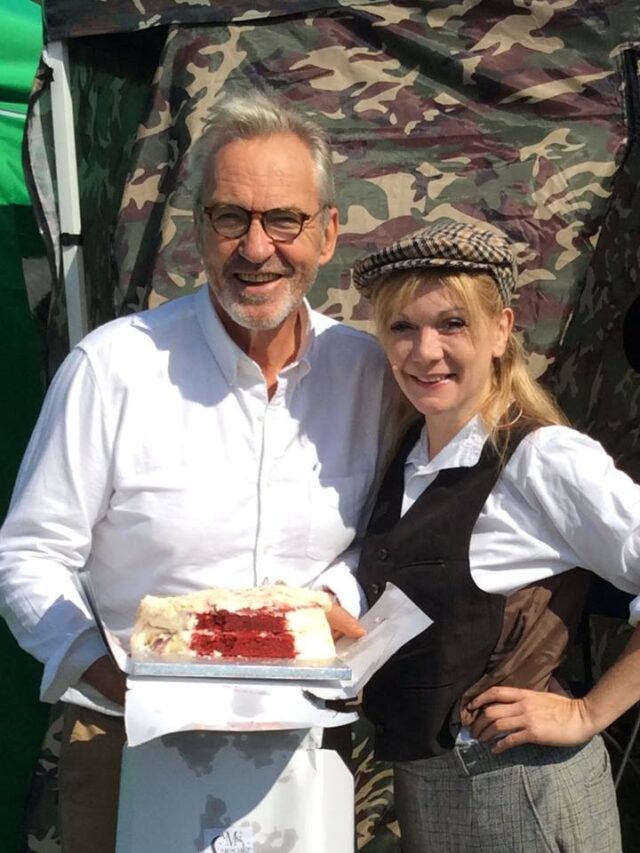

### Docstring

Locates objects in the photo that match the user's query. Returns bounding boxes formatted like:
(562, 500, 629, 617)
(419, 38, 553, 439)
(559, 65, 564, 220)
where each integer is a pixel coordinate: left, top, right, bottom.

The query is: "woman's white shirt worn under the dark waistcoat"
(402, 417, 640, 624)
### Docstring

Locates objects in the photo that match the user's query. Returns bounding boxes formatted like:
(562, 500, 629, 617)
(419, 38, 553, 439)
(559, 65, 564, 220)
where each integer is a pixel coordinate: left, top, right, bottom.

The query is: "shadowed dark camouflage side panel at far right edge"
(548, 48, 640, 481)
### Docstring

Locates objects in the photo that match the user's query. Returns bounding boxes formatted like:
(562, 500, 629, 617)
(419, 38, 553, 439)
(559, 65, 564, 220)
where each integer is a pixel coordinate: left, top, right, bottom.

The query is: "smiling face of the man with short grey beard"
(196, 133, 337, 331)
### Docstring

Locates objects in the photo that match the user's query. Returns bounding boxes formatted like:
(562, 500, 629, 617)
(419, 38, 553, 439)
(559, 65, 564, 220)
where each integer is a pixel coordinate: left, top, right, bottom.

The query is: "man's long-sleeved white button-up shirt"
(0, 287, 384, 711)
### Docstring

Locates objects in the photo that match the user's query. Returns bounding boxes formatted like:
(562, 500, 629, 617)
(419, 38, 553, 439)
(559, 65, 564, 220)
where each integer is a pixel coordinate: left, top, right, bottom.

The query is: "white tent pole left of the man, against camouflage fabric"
(43, 41, 89, 347)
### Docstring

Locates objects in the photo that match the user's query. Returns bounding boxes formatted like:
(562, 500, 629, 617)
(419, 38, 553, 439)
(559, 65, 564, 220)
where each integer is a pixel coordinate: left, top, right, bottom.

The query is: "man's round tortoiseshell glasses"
(202, 204, 325, 243)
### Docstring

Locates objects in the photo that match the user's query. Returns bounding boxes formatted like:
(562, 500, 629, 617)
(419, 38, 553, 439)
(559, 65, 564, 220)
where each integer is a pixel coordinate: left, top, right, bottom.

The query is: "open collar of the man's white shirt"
(195, 284, 314, 385)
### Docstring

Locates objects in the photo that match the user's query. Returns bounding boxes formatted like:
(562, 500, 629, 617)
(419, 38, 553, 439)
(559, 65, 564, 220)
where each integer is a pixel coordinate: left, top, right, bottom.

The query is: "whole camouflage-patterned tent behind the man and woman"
(22, 0, 640, 850)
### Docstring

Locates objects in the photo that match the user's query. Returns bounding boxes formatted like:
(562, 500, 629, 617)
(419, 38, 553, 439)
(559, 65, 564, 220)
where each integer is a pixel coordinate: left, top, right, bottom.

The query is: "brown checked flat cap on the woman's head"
(353, 220, 518, 305)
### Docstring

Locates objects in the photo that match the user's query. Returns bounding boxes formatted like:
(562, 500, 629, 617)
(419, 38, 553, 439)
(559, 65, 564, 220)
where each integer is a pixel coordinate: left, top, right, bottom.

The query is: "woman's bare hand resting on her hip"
(468, 687, 597, 753)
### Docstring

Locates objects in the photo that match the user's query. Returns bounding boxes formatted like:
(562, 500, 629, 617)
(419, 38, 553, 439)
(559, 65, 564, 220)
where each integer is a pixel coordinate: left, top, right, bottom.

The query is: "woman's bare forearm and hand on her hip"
(469, 625, 640, 753)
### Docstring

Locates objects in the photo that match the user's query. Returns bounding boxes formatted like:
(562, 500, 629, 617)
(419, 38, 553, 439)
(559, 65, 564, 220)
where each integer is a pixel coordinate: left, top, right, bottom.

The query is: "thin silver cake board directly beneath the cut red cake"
(129, 655, 351, 681)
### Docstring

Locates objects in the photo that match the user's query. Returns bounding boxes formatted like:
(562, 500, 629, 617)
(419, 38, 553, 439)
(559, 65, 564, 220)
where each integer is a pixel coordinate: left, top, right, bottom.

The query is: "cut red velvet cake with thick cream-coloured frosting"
(131, 584, 335, 661)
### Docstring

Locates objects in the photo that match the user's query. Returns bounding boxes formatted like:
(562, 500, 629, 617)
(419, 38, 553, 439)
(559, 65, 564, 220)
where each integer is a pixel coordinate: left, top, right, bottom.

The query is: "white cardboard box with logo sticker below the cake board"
(116, 729, 355, 853)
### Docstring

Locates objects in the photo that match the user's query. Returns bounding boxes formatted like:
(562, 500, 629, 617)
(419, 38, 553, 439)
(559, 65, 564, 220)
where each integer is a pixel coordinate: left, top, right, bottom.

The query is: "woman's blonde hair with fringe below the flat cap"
(370, 269, 567, 455)
